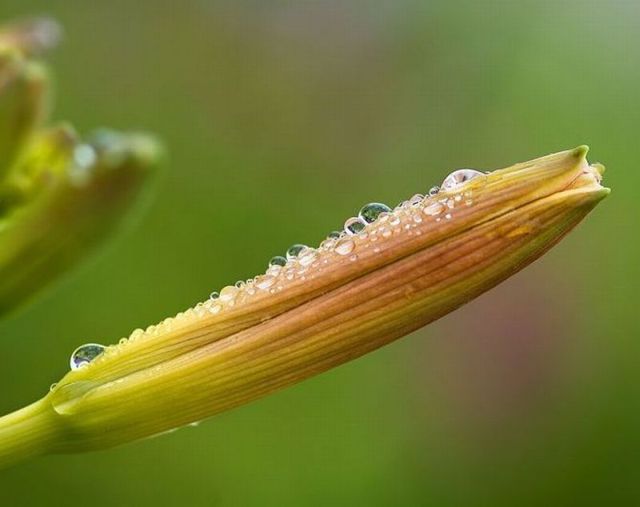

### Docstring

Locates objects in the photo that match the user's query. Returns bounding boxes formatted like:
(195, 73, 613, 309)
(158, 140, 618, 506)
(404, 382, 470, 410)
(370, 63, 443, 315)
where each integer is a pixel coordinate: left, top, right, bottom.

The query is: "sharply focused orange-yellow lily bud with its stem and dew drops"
(0, 147, 609, 465)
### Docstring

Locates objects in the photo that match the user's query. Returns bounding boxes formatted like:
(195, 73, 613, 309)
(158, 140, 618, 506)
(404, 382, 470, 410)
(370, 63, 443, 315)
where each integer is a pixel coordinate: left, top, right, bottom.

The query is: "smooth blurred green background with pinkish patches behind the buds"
(0, 0, 640, 507)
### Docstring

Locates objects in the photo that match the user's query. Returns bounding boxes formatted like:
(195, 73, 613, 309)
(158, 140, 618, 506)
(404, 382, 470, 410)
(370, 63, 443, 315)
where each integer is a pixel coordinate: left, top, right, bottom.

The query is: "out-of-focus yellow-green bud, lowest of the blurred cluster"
(0, 127, 160, 314)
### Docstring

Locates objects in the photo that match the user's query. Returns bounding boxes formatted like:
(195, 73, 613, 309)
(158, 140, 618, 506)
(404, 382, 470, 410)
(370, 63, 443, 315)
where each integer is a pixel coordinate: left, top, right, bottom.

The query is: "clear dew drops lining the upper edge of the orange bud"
(70, 169, 486, 370)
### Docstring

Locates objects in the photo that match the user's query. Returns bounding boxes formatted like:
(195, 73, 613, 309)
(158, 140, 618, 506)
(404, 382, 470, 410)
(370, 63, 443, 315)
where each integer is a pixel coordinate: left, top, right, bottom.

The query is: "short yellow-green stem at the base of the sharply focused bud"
(0, 400, 56, 470)
